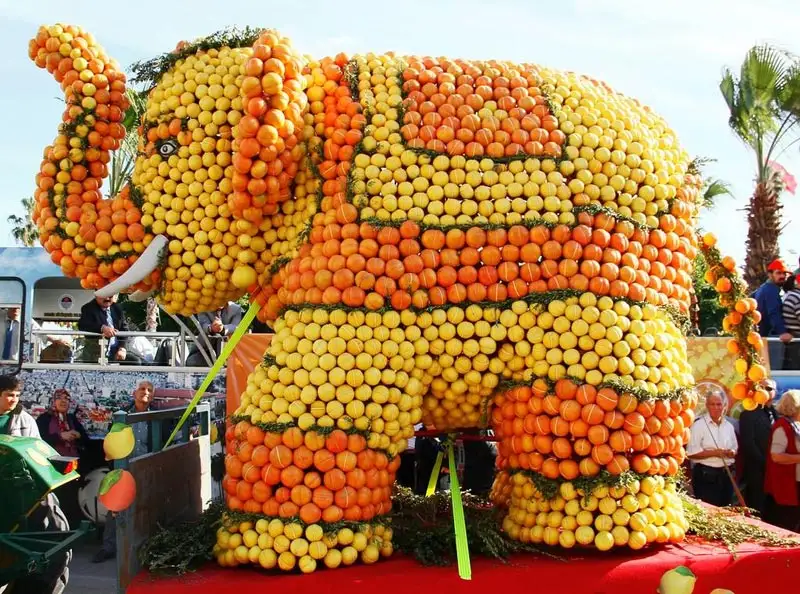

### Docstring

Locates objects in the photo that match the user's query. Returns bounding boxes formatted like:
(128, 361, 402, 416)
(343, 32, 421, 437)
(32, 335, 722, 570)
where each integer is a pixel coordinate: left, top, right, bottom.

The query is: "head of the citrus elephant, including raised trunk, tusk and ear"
(29, 25, 314, 315)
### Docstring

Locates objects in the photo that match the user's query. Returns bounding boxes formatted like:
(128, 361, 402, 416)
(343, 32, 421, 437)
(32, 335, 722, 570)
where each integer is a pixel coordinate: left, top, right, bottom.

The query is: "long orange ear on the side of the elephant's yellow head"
(228, 30, 308, 224)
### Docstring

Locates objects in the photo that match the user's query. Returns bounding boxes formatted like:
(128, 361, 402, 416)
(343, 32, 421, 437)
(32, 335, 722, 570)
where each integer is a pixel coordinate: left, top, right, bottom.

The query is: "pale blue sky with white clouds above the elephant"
(0, 0, 800, 262)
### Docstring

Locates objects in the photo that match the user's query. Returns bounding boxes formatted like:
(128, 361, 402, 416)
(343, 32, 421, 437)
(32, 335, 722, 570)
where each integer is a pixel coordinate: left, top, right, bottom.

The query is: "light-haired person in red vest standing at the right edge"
(764, 390, 800, 532)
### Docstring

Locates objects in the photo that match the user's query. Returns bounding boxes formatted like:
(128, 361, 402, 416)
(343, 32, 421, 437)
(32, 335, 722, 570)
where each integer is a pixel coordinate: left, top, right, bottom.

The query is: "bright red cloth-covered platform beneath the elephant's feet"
(127, 540, 800, 594)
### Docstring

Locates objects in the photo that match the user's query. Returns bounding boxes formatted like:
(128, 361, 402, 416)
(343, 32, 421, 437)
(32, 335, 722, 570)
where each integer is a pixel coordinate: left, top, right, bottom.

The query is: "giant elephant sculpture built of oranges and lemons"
(30, 25, 744, 571)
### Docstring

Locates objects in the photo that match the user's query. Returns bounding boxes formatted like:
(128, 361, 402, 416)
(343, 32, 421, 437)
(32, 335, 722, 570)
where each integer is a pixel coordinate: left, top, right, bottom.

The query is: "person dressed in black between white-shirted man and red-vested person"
(739, 379, 777, 517)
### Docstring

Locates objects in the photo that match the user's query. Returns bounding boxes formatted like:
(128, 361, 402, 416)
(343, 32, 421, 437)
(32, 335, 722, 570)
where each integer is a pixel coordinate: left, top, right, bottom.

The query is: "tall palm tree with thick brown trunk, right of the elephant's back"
(719, 45, 800, 289)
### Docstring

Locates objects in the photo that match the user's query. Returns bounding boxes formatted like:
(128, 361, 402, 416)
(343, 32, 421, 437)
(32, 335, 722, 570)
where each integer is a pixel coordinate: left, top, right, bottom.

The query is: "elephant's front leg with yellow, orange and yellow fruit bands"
(215, 307, 423, 571)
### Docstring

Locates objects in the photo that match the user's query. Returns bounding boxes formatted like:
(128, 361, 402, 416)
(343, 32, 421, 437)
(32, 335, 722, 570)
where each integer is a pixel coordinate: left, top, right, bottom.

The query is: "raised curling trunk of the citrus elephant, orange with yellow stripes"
(28, 25, 158, 290)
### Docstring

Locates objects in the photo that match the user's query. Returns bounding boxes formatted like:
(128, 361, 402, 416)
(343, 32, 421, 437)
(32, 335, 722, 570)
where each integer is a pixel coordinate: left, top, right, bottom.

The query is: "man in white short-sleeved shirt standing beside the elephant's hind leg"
(686, 392, 738, 507)
